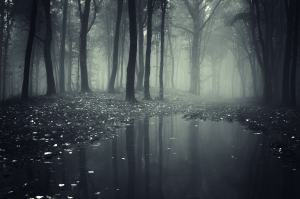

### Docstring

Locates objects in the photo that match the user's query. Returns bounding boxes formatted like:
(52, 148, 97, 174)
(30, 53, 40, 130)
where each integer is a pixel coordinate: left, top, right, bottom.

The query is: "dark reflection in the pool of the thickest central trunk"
(125, 125, 136, 199)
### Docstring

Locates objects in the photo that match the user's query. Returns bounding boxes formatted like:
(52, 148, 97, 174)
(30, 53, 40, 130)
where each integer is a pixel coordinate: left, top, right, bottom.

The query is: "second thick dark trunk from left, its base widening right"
(42, 0, 56, 96)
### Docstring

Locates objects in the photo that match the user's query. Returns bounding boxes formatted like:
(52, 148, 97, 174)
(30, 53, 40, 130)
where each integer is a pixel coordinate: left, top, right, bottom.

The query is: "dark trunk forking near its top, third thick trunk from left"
(79, 0, 91, 92)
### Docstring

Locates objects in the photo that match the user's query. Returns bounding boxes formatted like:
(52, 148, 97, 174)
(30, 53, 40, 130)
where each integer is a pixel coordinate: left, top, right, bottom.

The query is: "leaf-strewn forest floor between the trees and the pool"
(0, 88, 300, 177)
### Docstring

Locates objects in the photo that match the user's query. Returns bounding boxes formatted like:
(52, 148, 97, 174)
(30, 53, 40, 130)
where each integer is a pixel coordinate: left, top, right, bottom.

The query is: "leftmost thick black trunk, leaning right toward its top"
(21, 0, 38, 99)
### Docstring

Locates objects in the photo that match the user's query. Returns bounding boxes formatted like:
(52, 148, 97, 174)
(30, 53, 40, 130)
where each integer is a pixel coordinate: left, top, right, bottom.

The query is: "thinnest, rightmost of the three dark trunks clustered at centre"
(159, 0, 167, 100)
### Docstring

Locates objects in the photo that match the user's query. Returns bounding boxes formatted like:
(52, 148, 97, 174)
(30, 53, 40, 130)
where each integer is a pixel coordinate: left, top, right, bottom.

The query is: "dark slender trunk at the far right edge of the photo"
(290, 3, 300, 107)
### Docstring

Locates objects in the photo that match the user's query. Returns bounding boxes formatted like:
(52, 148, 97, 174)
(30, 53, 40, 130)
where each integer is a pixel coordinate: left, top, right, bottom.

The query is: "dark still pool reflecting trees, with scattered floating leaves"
(1, 115, 300, 199)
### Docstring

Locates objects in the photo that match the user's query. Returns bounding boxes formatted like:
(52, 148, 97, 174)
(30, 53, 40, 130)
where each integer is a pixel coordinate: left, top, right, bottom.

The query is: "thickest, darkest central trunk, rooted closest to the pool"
(126, 0, 137, 102)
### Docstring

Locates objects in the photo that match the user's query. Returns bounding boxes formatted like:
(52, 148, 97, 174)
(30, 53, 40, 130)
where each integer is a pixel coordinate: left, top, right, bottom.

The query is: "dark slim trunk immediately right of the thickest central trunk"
(144, 0, 153, 100)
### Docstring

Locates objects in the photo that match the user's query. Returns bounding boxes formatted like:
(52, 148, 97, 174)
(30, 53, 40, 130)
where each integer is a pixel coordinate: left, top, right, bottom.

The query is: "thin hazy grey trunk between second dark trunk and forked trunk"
(59, 0, 68, 93)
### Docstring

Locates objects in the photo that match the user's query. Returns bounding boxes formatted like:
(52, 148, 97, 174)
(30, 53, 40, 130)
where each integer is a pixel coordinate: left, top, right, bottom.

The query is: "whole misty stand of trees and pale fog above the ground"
(0, 0, 300, 106)
